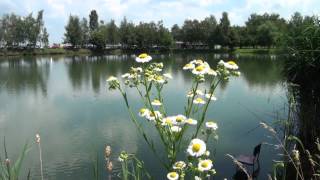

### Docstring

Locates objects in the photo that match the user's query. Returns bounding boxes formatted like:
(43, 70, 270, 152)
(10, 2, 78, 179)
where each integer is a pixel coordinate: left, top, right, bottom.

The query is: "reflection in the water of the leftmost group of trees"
(0, 58, 50, 95)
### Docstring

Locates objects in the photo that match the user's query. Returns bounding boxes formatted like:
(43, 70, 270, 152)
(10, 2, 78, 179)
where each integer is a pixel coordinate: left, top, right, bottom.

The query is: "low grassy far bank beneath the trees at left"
(0, 49, 93, 56)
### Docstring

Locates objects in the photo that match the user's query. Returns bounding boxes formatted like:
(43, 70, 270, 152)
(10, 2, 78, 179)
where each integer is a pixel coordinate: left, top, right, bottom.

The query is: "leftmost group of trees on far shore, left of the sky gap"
(0, 10, 49, 49)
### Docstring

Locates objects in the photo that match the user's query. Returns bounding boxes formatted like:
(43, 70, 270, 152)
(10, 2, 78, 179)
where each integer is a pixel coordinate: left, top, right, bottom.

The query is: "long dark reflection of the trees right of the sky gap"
(66, 53, 281, 93)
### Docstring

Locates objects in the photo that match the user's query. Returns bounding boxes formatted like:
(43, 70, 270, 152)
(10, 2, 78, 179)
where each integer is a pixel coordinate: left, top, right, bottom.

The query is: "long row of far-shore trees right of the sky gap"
(65, 10, 315, 49)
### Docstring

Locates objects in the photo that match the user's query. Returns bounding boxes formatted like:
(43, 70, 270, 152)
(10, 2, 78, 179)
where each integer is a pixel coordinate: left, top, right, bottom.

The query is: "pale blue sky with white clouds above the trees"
(0, 0, 320, 44)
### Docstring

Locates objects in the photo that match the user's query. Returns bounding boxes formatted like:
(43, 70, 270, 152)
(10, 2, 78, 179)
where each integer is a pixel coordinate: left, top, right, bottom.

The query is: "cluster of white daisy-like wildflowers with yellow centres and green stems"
(107, 54, 240, 180)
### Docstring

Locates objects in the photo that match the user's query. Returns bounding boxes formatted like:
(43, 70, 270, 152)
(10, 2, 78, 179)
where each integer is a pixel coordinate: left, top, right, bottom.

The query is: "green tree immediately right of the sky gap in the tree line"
(64, 15, 82, 47)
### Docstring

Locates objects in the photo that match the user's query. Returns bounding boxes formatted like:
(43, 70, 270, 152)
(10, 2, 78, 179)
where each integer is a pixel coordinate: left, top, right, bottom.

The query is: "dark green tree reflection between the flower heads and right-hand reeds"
(237, 56, 283, 88)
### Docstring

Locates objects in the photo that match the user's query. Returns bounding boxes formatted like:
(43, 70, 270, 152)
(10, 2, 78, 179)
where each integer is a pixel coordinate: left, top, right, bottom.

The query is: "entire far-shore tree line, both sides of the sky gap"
(0, 10, 318, 49)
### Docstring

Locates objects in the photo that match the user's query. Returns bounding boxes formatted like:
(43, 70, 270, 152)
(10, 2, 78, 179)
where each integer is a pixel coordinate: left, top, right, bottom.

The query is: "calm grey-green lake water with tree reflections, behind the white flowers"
(0, 54, 286, 179)
